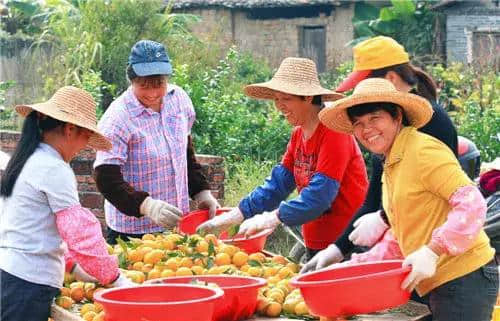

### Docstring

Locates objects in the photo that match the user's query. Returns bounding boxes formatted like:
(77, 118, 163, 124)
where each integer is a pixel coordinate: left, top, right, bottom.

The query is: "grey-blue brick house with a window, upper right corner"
(434, 0, 500, 71)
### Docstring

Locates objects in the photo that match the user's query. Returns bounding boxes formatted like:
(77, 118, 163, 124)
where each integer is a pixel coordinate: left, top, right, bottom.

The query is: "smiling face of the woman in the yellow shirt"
(351, 109, 402, 156)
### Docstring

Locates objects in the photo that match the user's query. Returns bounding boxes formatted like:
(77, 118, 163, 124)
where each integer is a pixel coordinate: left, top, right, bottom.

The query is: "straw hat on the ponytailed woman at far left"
(16, 86, 111, 150)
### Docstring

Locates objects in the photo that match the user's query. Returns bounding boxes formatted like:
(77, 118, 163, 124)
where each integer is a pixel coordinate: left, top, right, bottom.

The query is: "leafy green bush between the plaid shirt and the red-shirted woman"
(172, 48, 290, 162)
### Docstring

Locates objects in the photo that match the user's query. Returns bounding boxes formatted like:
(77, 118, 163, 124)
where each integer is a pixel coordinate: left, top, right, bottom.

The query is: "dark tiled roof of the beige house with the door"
(171, 0, 344, 9)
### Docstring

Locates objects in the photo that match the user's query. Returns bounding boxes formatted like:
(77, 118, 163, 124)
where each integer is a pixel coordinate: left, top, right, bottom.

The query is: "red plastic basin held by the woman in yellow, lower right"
(290, 261, 411, 317)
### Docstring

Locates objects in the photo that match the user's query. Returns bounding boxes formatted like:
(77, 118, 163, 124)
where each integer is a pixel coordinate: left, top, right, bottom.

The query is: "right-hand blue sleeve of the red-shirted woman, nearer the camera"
(279, 173, 340, 226)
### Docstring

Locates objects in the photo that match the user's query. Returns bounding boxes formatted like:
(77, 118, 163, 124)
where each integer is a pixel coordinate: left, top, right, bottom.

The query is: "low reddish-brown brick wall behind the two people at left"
(0, 131, 225, 226)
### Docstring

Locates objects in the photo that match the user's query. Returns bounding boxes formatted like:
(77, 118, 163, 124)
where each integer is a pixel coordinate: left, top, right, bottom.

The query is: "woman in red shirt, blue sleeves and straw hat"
(198, 58, 367, 259)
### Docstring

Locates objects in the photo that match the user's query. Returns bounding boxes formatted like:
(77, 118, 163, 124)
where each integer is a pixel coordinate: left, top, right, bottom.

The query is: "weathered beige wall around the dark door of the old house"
(183, 5, 354, 69)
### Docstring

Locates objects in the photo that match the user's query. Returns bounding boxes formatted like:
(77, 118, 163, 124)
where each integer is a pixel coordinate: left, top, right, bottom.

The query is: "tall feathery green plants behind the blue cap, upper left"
(32, 0, 197, 106)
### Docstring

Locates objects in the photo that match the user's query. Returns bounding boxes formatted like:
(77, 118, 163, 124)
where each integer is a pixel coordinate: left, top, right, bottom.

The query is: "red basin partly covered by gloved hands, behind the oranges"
(179, 208, 273, 253)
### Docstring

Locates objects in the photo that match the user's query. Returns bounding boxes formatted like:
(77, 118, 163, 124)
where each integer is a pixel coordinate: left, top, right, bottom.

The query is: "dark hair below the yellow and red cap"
(369, 63, 437, 101)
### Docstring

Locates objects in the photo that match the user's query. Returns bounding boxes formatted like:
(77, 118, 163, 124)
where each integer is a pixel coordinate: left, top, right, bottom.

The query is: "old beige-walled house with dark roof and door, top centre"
(173, 0, 354, 71)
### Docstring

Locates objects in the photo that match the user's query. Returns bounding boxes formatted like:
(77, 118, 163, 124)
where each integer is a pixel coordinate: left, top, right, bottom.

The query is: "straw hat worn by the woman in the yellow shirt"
(319, 78, 433, 134)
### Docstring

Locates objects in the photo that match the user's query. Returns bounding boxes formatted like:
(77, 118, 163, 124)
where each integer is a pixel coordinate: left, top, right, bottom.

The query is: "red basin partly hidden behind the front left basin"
(147, 275, 266, 321)
